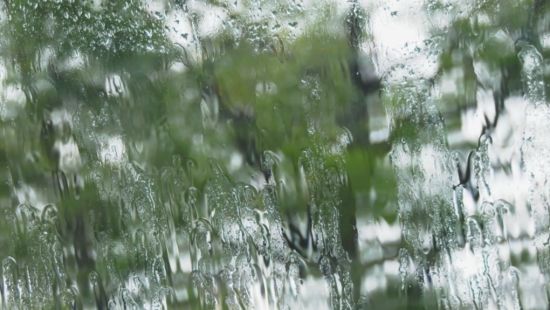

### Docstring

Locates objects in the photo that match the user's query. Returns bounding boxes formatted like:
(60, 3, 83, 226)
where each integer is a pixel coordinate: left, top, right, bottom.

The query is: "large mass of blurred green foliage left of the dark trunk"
(0, 0, 395, 308)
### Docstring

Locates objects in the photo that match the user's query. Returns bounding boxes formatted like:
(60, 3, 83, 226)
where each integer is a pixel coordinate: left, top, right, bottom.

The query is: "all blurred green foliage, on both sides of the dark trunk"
(4, 0, 548, 308)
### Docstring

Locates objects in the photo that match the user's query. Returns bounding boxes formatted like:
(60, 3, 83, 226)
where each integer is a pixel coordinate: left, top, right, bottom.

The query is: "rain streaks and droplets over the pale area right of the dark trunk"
(380, 0, 549, 309)
